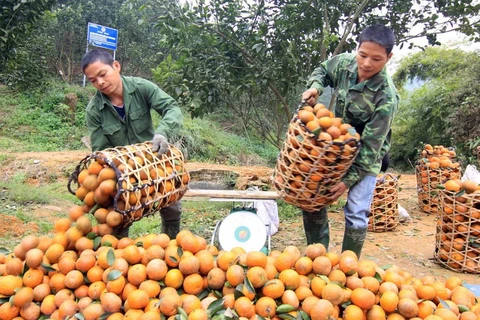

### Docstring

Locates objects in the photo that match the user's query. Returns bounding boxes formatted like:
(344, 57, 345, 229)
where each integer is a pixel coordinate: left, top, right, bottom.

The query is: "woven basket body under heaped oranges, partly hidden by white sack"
(415, 157, 462, 214)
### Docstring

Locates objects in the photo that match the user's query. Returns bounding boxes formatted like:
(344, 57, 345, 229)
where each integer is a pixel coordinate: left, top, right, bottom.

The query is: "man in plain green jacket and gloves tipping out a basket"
(82, 49, 183, 238)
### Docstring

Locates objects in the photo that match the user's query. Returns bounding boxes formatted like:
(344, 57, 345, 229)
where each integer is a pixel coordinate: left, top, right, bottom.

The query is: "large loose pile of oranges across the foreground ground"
(0, 196, 480, 320)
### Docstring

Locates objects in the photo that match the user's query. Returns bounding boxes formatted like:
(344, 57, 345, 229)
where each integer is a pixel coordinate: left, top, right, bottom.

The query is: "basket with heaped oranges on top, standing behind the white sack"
(415, 144, 461, 214)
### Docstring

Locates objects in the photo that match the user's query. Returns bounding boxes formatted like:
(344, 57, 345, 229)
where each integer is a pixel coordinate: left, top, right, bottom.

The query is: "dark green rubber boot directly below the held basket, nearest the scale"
(302, 208, 330, 251)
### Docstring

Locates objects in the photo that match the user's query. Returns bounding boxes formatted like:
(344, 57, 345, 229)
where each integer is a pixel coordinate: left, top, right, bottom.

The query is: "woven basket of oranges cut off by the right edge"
(434, 190, 480, 273)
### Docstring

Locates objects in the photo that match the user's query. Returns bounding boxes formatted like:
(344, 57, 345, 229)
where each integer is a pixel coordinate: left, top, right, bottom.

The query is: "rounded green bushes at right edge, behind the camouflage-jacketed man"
(391, 47, 480, 168)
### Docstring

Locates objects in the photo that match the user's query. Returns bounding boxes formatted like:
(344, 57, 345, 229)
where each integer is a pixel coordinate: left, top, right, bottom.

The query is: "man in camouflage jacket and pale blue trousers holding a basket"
(302, 25, 399, 257)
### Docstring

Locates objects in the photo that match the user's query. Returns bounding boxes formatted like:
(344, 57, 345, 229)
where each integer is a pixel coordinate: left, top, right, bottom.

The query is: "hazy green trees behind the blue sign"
(0, 0, 169, 88)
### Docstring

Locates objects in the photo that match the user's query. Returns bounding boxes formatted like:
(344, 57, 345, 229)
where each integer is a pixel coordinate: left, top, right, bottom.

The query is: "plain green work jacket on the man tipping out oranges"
(86, 76, 183, 151)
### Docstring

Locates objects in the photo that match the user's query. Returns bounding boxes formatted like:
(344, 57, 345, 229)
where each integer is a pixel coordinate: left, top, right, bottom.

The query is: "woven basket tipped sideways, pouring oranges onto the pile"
(68, 141, 190, 228)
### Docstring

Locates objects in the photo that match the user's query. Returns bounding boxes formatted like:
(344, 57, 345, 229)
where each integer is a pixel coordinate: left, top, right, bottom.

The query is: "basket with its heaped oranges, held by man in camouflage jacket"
(273, 103, 360, 212)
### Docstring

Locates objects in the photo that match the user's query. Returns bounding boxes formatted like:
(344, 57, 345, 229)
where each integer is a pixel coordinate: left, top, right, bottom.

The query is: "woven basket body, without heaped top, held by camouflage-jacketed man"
(273, 111, 360, 212)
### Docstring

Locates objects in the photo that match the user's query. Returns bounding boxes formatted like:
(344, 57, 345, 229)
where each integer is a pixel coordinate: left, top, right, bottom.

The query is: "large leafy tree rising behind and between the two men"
(154, 0, 480, 147)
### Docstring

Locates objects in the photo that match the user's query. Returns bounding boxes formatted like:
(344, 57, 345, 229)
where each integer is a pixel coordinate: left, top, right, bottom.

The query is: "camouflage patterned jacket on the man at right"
(308, 53, 399, 188)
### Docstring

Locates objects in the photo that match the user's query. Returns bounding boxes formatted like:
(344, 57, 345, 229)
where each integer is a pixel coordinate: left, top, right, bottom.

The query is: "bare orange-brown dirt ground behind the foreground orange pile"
(0, 151, 480, 284)
